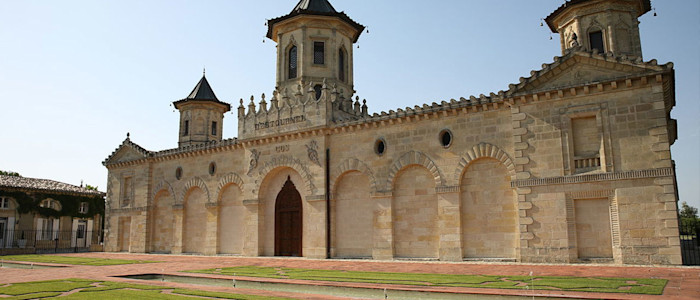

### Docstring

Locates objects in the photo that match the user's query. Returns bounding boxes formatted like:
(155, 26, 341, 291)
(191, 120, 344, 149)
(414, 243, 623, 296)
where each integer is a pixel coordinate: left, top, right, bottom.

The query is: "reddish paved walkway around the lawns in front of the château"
(0, 253, 700, 300)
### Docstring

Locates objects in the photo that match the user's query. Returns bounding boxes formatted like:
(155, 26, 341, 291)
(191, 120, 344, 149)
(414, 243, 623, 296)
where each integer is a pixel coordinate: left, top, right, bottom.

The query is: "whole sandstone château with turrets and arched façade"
(104, 0, 681, 264)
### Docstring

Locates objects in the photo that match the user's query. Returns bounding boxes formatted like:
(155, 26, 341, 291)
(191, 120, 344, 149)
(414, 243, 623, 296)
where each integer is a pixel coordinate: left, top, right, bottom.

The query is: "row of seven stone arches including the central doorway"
(141, 156, 520, 259)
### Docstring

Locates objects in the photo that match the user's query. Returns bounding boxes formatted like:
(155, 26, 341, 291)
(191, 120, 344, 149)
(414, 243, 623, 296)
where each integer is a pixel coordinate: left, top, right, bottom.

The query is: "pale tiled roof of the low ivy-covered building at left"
(0, 175, 104, 196)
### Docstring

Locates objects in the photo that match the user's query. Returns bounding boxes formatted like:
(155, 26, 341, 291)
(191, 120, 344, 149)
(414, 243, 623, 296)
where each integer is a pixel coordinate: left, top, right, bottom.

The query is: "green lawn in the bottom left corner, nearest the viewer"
(0, 279, 292, 300)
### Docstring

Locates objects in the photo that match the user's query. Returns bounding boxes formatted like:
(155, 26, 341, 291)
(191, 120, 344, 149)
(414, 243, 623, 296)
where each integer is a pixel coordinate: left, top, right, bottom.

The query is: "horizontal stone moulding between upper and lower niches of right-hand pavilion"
(510, 168, 673, 188)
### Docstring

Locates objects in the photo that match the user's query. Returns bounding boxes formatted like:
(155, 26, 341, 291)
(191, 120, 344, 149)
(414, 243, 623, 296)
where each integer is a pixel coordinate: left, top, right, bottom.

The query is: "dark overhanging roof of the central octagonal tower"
(267, 0, 365, 43)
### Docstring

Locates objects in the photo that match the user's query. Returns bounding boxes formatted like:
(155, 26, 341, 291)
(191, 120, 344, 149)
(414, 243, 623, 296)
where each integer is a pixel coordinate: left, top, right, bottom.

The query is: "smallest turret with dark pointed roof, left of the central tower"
(173, 75, 231, 147)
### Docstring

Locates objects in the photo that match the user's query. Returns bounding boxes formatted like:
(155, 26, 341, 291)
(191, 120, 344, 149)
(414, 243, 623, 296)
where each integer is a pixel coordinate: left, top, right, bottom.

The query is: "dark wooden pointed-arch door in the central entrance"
(275, 176, 303, 256)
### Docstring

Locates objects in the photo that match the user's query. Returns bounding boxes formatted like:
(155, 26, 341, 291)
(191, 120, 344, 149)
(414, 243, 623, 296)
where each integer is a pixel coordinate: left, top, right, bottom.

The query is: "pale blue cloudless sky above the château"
(0, 0, 700, 207)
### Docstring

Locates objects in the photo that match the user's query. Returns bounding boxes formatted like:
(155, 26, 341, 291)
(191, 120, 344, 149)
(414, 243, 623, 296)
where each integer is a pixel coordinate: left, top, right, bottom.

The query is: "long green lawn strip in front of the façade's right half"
(187, 266, 668, 295)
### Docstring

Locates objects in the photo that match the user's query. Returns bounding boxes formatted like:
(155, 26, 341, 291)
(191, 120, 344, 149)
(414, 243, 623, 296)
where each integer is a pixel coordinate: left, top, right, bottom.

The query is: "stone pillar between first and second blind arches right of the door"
(372, 192, 394, 260)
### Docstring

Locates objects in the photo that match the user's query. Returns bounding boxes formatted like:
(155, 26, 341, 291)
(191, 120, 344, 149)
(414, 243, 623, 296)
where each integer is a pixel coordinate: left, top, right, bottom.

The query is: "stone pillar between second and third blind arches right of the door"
(435, 186, 462, 261)
